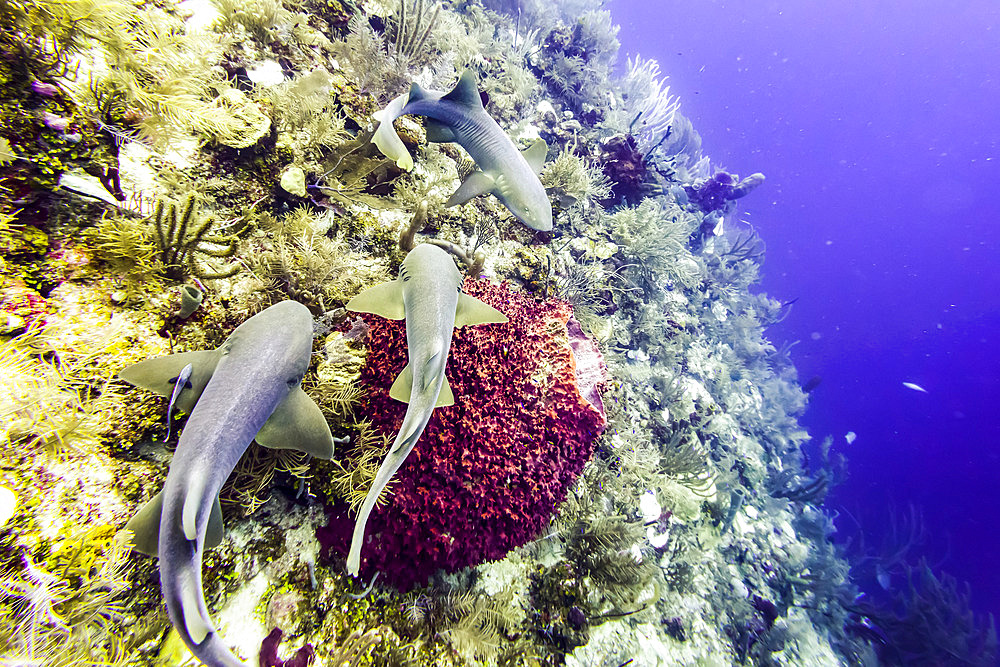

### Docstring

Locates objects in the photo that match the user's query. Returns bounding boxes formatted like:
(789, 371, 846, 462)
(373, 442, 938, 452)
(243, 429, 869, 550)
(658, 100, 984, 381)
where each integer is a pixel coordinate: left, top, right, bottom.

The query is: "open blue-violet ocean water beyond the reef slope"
(609, 0, 1000, 614)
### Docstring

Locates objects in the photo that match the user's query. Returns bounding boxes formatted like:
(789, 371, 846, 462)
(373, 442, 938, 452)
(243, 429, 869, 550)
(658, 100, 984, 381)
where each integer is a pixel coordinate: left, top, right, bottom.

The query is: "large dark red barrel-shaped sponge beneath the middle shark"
(319, 279, 607, 590)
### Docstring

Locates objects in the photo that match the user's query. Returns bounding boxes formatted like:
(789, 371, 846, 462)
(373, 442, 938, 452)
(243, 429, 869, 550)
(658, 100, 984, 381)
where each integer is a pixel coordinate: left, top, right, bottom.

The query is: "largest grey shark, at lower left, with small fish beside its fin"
(119, 301, 334, 667)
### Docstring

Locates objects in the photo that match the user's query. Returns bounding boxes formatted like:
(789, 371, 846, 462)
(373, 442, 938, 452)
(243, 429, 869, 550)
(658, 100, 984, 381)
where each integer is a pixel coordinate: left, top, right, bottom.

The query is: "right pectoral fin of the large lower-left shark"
(257, 387, 333, 459)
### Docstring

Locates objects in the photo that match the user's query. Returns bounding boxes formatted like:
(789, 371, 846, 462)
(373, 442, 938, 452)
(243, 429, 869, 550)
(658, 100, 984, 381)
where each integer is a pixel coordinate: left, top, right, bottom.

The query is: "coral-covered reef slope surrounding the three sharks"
(0, 0, 936, 666)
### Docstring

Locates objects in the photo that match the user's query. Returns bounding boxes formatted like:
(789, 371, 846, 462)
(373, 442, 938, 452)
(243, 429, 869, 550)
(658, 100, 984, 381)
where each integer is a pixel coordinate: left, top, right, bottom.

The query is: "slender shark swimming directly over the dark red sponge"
(347, 244, 507, 576)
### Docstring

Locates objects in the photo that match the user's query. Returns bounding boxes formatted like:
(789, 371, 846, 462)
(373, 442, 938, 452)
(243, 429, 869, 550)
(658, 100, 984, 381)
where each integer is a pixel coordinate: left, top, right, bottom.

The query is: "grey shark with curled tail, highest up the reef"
(372, 71, 552, 231)
